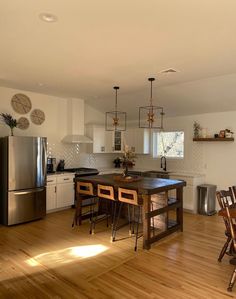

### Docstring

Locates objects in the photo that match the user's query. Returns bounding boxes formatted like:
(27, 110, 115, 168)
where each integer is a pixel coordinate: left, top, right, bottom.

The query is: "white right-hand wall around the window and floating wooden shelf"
(132, 111, 236, 189)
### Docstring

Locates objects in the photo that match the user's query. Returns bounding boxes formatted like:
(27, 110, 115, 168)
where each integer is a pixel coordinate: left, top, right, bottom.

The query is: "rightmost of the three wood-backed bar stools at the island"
(112, 188, 143, 251)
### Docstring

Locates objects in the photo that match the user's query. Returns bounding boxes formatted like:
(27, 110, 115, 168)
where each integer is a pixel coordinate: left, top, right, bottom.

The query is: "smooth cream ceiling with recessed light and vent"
(0, 0, 236, 119)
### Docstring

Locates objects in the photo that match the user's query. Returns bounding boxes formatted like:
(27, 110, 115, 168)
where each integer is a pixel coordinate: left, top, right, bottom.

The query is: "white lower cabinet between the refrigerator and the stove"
(46, 174, 75, 213)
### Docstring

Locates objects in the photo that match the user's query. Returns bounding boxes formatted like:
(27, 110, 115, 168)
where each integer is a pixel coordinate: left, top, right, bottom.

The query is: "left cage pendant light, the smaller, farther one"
(105, 86, 126, 131)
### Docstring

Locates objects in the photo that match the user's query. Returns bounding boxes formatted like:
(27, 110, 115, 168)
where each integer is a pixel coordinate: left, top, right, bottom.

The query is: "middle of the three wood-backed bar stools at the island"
(90, 184, 117, 236)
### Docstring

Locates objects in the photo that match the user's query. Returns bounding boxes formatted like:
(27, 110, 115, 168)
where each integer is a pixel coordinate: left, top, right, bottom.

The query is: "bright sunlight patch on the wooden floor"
(25, 244, 109, 267)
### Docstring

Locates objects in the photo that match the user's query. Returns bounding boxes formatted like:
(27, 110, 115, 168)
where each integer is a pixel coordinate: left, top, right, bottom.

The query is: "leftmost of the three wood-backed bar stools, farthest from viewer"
(72, 182, 97, 227)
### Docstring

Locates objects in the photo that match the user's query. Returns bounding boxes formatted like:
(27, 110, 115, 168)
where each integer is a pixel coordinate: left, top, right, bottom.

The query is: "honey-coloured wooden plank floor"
(0, 210, 236, 299)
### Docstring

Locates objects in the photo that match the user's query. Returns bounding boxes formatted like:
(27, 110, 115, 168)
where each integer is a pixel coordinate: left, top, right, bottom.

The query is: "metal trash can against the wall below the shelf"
(197, 184, 216, 216)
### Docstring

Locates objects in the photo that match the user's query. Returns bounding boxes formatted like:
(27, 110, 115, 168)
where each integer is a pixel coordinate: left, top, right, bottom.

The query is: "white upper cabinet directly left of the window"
(124, 128, 150, 154)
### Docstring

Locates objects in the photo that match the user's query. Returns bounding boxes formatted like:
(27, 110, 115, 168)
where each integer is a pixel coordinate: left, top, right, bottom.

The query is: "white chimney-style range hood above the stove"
(62, 99, 93, 143)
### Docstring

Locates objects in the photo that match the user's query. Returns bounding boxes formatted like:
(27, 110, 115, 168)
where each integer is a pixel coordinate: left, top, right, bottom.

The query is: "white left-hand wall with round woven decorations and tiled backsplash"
(0, 87, 113, 168)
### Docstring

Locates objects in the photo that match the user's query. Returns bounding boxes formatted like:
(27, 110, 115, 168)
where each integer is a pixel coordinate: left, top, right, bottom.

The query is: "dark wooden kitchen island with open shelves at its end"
(74, 174, 186, 249)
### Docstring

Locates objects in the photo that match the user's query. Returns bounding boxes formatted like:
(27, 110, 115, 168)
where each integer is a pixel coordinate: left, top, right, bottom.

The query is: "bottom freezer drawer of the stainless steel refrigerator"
(4, 188, 46, 225)
